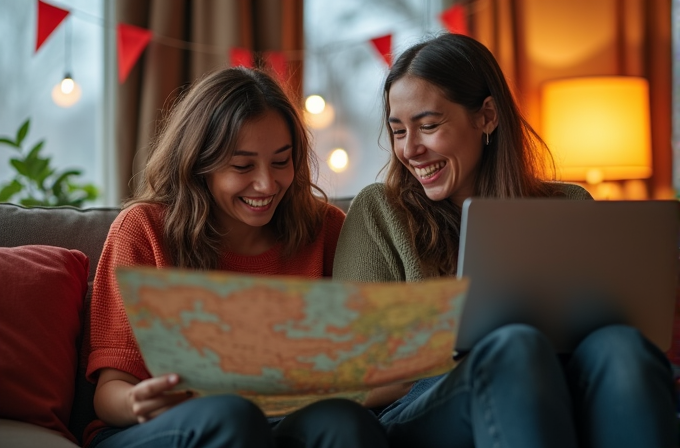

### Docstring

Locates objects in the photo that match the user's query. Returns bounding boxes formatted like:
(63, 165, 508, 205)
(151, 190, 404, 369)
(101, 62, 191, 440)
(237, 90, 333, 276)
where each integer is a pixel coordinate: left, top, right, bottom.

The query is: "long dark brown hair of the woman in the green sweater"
(383, 34, 557, 276)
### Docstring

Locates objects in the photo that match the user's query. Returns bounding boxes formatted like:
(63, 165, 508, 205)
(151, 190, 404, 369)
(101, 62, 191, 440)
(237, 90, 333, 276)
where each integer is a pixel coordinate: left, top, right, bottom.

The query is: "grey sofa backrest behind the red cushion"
(0, 204, 120, 441)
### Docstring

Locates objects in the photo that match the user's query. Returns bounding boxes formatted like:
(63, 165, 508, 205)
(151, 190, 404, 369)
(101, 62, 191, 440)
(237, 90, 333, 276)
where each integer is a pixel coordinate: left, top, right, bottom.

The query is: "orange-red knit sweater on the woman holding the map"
(85, 204, 345, 443)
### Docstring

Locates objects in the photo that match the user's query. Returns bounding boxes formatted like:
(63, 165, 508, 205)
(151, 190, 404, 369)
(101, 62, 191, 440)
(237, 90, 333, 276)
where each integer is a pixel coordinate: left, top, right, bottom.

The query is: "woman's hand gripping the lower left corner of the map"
(128, 373, 193, 423)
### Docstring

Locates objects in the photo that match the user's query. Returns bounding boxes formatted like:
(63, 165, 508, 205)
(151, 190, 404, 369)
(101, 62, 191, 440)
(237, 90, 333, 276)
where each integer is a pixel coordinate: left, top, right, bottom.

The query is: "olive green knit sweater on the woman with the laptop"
(333, 183, 592, 282)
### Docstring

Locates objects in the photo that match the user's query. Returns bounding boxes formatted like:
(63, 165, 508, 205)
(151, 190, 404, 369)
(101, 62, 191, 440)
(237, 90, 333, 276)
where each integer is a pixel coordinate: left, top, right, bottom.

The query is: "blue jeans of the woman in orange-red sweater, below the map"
(90, 395, 387, 448)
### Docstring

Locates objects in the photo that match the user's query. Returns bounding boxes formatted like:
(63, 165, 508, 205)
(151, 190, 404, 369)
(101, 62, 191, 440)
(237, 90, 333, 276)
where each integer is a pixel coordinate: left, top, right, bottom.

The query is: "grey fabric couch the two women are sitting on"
(0, 198, 351, 448)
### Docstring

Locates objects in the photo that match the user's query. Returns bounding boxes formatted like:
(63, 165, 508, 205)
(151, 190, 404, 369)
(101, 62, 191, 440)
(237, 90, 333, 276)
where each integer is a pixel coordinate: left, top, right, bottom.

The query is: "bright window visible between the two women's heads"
(304, 0, 444, 197)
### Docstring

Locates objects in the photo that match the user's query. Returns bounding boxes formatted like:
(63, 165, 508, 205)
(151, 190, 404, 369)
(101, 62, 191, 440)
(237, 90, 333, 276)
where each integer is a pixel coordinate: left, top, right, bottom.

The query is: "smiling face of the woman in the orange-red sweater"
(206, 110, 294, 243)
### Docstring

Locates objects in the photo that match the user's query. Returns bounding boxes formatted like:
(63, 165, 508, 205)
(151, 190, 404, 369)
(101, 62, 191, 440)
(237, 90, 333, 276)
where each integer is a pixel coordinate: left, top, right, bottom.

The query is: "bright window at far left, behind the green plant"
(0, 0, 116, 205)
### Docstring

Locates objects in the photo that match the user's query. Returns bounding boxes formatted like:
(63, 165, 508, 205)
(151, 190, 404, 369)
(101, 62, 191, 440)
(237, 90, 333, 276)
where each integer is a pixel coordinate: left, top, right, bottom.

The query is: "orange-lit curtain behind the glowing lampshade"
(461, 0, 674, 198)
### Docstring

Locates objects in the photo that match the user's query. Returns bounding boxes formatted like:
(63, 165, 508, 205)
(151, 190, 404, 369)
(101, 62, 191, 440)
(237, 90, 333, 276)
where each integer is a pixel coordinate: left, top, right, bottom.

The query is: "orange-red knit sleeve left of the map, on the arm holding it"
(87, 205, 169, 381)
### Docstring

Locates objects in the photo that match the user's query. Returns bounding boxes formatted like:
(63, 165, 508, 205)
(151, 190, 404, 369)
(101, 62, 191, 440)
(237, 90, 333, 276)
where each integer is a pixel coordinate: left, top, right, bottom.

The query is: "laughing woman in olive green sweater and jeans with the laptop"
(333, 34, 675, 448)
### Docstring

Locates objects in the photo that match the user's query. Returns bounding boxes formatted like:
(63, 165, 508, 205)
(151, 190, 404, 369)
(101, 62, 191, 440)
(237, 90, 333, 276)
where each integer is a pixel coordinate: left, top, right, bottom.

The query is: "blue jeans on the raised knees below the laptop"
(379, 325, 677, 448)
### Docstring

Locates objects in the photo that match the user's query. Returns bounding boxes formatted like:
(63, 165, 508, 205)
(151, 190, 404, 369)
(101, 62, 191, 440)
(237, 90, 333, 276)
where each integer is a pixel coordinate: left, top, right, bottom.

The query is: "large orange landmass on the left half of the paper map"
(137, 286, 364, 375)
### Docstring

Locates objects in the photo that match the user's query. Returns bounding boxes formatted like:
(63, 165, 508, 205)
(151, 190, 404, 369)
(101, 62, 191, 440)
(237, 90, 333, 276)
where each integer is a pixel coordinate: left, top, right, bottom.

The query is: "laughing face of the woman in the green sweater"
(388, 76, 496, 205)
